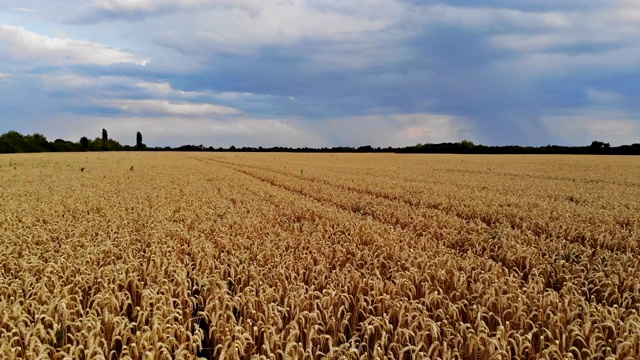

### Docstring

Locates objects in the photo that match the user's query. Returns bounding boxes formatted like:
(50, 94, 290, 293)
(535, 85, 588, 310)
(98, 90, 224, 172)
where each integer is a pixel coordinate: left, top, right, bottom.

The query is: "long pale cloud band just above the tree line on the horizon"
(43, 114, 470, 147)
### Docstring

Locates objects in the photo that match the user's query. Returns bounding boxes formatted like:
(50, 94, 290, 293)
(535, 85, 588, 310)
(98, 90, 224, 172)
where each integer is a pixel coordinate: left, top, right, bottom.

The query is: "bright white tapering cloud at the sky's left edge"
(0, 25, 149, 65)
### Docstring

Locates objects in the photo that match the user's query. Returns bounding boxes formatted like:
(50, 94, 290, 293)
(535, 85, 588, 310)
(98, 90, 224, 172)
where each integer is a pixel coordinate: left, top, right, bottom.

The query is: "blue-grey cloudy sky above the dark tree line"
(0, 0, 640, 147)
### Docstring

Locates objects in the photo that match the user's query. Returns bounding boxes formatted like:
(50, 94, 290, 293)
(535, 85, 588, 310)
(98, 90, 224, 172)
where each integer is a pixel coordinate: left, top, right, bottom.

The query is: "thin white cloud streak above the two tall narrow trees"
(96, 99, 241, 116)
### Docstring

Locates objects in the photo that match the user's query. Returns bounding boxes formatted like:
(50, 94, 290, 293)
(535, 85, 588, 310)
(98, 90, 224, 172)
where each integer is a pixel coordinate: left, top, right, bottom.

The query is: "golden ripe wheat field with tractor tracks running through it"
(0, 153, 640, 359)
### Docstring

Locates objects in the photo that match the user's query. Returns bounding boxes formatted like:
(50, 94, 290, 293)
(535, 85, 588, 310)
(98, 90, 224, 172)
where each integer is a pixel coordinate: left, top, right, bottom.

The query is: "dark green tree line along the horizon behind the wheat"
(0, 129, 640, 155)
